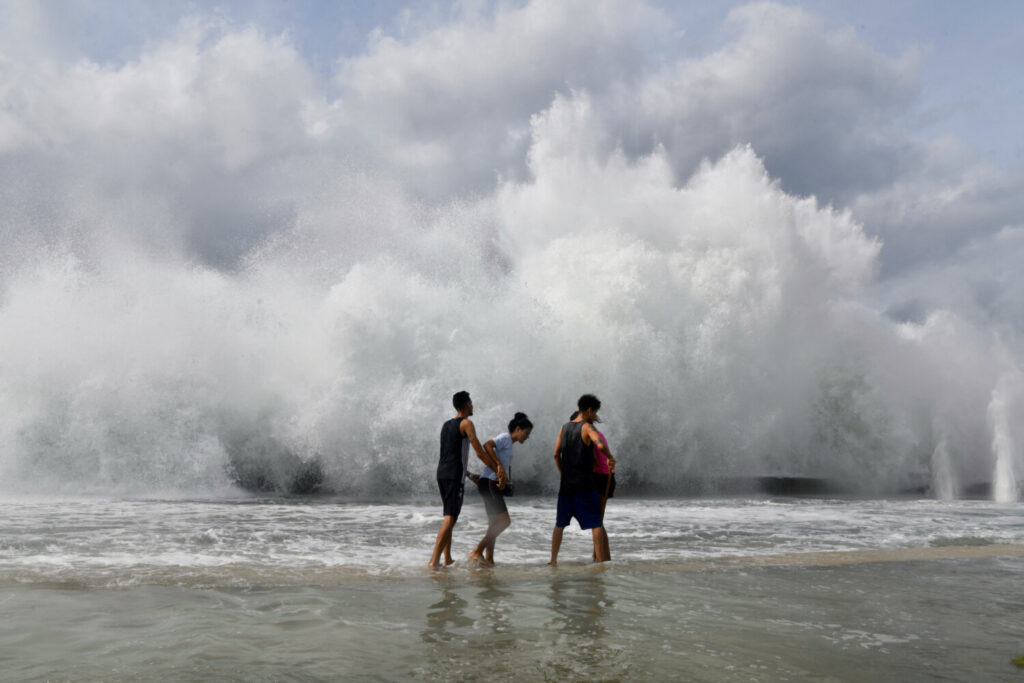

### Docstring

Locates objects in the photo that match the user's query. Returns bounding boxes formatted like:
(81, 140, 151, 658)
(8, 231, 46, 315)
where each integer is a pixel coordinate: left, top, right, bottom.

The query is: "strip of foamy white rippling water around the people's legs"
(0, 498, 1024, 588)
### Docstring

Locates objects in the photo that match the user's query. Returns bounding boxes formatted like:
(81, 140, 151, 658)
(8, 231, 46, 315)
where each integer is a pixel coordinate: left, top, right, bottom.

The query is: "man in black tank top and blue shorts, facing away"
(550, 393, 615, 566)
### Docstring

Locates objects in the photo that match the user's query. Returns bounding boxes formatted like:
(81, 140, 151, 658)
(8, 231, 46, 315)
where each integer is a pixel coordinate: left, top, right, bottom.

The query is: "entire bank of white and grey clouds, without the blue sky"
(0, 0, 1022, 274)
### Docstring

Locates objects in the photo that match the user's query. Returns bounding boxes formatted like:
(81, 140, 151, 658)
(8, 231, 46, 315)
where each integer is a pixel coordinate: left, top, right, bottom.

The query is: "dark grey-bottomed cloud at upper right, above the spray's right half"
(636, 3, 919, 201)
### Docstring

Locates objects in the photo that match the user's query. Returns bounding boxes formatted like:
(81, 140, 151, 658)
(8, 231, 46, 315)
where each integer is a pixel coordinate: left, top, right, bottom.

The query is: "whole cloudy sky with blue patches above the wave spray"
(0, 0, 1024, 331)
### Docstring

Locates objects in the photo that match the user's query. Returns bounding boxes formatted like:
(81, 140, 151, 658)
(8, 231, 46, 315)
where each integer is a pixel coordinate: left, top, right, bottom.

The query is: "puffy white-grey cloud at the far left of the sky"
(0, 22, 323, 265)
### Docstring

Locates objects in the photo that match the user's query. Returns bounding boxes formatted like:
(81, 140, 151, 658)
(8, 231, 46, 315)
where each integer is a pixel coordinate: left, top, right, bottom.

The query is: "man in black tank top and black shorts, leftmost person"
(427, 391, 484, 568)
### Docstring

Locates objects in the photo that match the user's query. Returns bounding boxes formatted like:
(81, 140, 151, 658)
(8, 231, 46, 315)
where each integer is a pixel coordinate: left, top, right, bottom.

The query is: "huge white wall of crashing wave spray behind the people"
(0, 126, 1013, 495)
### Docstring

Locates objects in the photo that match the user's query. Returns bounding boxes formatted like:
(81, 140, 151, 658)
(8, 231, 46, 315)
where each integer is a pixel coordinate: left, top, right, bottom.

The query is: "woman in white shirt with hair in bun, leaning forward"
(469, 413, 534, 565)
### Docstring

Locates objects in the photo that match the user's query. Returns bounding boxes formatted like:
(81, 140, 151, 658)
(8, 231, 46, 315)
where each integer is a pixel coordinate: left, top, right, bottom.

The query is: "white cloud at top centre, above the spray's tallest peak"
(336, 0, 666, 195)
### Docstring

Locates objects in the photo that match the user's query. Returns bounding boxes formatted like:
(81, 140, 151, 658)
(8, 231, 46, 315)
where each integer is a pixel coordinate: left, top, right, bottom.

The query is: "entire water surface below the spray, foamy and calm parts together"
(0, 496, 1024, 682)
